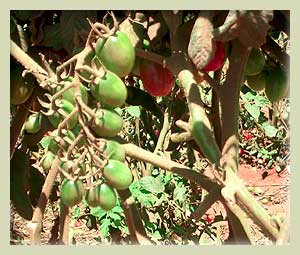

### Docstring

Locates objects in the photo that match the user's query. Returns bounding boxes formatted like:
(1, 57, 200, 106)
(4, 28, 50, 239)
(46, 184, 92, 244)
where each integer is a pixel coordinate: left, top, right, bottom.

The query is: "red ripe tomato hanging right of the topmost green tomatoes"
(140, 61, 174, 96)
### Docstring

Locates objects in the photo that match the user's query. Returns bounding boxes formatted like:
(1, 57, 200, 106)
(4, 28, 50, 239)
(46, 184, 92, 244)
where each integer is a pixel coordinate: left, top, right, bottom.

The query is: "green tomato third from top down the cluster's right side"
(91, 109, 123, 138)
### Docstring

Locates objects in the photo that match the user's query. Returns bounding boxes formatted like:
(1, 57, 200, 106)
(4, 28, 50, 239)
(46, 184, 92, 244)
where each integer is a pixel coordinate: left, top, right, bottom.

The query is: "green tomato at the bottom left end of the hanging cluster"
(60, 179, 83, 207)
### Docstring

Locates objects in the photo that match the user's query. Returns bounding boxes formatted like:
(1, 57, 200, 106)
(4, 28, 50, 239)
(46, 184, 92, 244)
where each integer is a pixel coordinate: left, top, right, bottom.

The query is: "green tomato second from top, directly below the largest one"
(91, 71, 127, 108)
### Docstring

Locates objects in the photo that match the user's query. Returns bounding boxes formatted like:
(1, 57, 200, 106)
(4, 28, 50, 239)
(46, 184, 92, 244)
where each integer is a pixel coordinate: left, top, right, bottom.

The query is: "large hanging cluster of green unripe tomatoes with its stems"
(12, 31, 152, 210)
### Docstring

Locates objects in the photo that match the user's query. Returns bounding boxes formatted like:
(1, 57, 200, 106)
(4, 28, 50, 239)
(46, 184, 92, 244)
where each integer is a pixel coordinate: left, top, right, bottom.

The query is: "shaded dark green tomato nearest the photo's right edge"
(265, 67, 289, 102)
